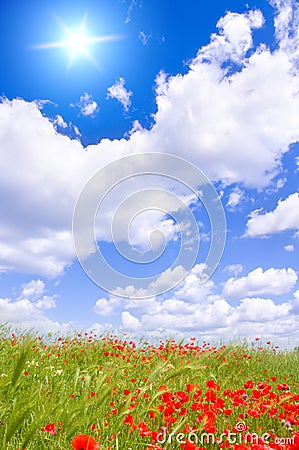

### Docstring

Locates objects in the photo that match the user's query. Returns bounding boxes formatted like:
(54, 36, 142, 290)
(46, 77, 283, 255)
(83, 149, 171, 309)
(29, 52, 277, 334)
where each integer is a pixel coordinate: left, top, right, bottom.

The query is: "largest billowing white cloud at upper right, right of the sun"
(152, 15, 299, 187)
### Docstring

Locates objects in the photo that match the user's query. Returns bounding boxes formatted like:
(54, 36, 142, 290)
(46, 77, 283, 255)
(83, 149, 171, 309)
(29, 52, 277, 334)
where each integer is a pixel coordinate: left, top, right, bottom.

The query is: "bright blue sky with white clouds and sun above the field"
(0, 0, 299, 347)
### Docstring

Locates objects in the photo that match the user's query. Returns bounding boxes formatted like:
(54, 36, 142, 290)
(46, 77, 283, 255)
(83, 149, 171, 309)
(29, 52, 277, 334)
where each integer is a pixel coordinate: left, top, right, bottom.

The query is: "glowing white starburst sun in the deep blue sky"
(33, 14, 121, 70)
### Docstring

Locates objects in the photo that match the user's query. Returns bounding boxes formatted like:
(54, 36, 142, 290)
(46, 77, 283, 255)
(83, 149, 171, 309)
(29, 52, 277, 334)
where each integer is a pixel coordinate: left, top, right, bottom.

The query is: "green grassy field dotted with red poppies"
(0, 326, 299, 450)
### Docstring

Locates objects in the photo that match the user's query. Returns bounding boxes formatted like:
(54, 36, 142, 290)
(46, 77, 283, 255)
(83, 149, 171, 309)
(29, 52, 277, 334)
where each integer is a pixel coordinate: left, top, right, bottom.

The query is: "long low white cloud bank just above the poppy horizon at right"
(121, 297, 299, 341)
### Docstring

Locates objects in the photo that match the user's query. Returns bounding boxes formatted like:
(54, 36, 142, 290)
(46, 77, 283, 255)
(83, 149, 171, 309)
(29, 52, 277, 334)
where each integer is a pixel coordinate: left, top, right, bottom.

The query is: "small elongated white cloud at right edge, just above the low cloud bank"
(222, 267, 298, 298)
